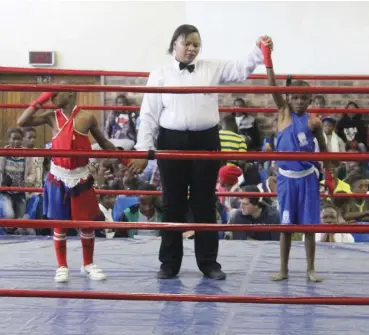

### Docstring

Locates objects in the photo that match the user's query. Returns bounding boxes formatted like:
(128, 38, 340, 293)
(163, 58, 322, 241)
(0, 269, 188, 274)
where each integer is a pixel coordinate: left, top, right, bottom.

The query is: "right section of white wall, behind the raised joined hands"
(186, 1, 369, 74)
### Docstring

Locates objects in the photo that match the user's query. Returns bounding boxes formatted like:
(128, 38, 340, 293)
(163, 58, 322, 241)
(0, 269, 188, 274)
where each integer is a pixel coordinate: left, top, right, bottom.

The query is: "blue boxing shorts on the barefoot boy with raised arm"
(277, 172, 320, 224)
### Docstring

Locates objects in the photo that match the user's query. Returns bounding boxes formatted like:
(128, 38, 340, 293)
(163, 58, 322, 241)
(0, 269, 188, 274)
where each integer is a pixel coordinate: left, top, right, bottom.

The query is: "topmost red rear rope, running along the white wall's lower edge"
(0, 67, 369, 80)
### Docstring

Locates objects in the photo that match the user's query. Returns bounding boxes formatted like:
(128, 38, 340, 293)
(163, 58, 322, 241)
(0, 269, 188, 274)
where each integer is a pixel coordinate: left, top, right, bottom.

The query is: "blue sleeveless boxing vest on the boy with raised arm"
(276, 112, 317, 171)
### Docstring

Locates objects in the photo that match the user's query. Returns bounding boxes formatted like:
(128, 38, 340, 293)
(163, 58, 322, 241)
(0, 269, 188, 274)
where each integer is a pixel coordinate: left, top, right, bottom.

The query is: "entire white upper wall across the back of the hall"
(0, 0, 369, 74)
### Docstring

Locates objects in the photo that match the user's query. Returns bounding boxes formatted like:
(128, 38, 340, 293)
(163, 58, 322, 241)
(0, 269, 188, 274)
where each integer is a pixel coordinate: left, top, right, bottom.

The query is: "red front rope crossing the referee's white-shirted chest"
(0, 84, 369, 94)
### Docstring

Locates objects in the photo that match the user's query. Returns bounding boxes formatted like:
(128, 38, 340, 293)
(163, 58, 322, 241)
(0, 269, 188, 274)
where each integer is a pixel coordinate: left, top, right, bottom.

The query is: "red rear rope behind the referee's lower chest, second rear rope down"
(0, 103, 369, 114)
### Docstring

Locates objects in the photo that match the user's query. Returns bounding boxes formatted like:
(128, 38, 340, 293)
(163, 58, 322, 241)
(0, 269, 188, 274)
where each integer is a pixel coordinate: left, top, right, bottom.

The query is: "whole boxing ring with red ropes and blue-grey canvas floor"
(0, 68, 369, 335)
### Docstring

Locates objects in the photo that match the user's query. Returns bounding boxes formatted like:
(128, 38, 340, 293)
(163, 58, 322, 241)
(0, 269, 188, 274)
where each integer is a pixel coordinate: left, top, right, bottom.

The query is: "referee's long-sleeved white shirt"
(135, 46, 263, 150)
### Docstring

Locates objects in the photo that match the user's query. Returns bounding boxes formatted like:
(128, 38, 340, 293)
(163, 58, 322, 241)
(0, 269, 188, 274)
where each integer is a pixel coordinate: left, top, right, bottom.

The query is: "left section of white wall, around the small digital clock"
(0, 0, 185, 71)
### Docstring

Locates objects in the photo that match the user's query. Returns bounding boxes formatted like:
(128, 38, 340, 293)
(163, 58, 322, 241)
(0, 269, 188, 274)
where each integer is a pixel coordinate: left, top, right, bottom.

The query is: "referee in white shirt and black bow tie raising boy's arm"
(129, 24, 272, 280)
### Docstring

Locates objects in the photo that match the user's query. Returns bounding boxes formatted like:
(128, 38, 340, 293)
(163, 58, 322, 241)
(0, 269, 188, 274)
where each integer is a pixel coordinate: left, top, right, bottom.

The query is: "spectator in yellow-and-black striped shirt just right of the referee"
(219, 115, 247, 165)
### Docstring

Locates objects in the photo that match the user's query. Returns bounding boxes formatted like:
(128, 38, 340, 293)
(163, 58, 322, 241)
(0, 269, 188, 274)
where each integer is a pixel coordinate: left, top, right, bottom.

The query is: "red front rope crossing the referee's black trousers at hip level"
(0, 149, 369, 161)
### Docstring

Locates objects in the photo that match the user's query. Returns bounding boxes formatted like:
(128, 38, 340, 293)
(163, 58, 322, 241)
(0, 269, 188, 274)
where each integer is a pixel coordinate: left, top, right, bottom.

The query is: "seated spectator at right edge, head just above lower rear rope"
(343, 174, 369, 222)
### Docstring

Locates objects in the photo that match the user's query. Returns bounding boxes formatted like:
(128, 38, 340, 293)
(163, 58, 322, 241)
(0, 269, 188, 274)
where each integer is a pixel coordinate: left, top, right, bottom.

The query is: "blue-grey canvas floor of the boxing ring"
(0, 236, 369, 335)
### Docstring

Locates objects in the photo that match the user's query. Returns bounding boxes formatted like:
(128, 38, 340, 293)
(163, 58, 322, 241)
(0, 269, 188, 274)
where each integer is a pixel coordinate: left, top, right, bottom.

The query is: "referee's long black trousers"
(157, 126, 221, 275)
